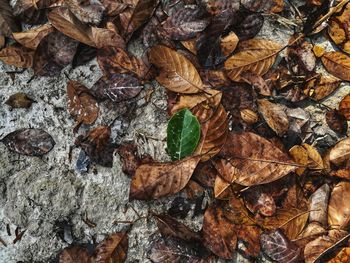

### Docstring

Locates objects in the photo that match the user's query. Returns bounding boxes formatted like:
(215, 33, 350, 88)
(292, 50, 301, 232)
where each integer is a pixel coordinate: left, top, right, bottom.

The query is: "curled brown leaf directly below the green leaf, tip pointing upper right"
(130, 157, 200, 199)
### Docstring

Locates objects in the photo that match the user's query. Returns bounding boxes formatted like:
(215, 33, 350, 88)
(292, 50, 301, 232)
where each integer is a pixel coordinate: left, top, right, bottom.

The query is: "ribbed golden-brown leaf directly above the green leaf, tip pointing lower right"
(149, 45, 203, 94)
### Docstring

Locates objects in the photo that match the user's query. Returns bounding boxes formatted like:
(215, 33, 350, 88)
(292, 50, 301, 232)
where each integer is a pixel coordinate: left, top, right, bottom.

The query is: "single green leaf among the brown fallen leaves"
(167, 109, 201, 160)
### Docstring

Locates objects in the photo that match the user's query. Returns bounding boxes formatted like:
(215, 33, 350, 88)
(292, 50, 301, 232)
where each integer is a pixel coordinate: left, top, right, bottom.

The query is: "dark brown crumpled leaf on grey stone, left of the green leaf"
(76, 126, 114, 167)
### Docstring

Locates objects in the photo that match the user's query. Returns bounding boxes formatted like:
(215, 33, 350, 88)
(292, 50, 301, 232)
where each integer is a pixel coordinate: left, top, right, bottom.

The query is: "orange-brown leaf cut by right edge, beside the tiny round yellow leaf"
(321, 51, 350, 81)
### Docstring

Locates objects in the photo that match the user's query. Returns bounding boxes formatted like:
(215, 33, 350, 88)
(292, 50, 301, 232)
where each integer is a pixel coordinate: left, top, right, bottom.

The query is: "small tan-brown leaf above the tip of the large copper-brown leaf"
(258, 100, 289, 136)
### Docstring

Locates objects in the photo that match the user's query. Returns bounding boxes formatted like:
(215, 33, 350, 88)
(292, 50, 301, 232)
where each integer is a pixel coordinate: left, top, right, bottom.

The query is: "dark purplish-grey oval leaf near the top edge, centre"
(162, 5, 209, 40)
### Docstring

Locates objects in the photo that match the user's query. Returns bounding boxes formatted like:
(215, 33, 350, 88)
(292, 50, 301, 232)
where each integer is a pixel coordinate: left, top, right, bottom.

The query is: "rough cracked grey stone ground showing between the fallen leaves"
(0, 9, 350, 263)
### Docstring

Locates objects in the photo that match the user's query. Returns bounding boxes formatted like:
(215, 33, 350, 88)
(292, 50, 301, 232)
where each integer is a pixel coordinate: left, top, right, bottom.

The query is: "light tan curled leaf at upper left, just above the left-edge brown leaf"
(13, 24, 54, 50)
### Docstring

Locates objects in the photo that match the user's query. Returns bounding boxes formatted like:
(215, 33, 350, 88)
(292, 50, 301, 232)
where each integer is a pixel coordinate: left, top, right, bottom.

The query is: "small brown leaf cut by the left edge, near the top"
(0, 45, 34, 68)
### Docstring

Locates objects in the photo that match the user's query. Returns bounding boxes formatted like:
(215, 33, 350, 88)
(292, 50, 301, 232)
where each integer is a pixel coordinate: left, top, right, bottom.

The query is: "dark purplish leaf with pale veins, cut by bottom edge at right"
(260, 229, 301, 263)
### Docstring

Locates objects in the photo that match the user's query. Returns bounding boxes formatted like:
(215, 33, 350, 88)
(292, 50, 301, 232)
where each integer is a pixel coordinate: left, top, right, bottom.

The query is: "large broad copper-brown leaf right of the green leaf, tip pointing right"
(220, 132, 296, 186)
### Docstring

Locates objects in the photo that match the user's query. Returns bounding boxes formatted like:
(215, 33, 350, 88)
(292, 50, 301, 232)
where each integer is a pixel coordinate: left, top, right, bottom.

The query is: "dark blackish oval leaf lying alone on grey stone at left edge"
(1, 129, 55, 156)
